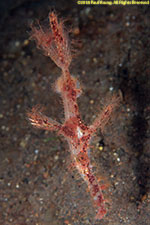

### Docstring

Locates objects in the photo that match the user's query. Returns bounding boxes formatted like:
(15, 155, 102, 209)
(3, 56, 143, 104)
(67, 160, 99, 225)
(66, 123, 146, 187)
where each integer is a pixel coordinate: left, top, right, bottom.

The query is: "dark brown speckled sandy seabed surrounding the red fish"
(0, 0, 150, 225)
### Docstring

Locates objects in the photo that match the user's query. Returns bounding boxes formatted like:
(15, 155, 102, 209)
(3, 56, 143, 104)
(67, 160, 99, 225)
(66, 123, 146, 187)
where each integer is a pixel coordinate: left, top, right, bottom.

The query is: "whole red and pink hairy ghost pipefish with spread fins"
(28, 12, 119, 219)
